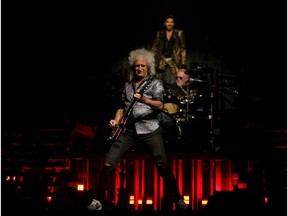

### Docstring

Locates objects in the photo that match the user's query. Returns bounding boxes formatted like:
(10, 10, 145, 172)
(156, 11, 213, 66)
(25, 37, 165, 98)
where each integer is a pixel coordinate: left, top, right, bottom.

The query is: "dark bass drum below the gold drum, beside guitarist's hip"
(158, 111, 180, 148)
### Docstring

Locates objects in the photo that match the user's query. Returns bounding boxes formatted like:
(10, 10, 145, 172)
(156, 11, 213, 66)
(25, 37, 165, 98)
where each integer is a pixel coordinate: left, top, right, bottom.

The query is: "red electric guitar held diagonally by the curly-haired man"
(107, 80, 151, 143)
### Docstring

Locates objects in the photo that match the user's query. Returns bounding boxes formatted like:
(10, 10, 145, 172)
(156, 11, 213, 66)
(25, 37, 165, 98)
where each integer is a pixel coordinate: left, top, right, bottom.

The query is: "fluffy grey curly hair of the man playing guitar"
(128, 48, 156, 81)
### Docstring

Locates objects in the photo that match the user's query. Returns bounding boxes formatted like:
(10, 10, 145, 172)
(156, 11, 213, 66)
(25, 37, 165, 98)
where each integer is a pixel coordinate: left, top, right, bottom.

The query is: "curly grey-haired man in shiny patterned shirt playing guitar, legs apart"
(87, 49, 188, 210)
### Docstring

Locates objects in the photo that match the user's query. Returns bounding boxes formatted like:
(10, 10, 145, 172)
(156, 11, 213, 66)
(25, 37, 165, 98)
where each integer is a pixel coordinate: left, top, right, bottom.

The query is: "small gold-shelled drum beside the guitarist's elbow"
(164, 89, 180, 114)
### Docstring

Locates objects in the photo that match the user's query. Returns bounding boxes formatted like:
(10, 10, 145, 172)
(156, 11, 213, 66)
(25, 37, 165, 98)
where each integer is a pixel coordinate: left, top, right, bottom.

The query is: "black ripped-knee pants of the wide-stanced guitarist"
(97, 128, 183, 205)
